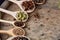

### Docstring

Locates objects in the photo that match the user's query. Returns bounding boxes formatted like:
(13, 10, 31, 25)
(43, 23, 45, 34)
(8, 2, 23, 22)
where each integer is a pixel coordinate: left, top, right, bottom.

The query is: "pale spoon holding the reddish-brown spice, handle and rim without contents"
(8, 0, 35, 13)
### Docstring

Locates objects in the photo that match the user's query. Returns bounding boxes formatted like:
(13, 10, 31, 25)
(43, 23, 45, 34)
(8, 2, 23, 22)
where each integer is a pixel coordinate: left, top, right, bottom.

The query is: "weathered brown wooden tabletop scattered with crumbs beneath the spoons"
(1, 0, 60, 40)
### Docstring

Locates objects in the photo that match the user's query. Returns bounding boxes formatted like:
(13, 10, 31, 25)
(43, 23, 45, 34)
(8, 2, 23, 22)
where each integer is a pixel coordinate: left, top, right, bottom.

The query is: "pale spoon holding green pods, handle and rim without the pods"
(0, 8, 28, 22)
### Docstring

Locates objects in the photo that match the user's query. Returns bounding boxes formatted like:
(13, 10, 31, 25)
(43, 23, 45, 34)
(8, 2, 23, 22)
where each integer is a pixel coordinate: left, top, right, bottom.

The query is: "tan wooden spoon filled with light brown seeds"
(0, 27, 25, 36)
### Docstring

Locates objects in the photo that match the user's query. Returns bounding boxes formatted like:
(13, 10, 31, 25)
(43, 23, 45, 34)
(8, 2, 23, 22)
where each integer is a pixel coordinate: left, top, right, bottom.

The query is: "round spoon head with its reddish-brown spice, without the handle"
(21, 0, 35, 13)
